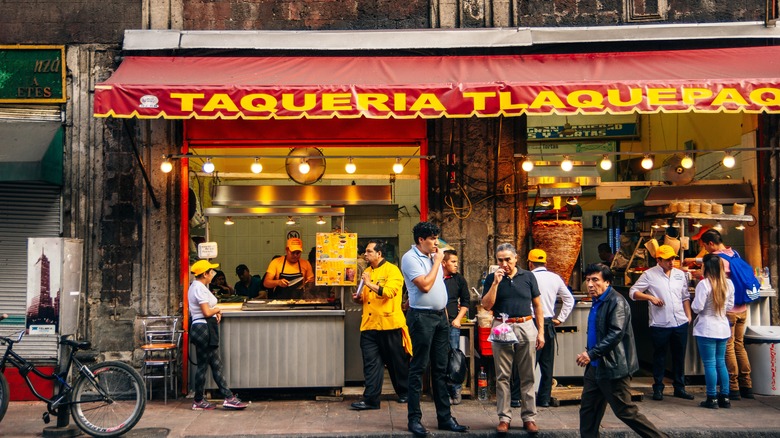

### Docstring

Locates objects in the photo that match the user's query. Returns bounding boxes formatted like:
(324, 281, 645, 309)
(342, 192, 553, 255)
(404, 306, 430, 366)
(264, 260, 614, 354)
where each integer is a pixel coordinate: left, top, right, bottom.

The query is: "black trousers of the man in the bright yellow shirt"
(360, 329, 409, 406)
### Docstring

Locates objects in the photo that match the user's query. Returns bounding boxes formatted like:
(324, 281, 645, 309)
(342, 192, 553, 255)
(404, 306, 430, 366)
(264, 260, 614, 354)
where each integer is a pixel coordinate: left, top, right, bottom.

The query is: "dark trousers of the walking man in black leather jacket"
(580, 365, 668, 438)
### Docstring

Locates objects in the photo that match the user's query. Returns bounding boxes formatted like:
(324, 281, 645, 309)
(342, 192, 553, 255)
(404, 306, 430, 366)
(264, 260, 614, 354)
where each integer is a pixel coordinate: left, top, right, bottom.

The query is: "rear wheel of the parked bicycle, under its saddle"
(70, 362, 146, 437)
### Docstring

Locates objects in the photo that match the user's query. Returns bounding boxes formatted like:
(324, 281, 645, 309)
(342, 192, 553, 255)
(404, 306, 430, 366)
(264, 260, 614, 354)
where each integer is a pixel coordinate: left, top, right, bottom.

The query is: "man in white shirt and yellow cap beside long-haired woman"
(628, 245, 693, 400)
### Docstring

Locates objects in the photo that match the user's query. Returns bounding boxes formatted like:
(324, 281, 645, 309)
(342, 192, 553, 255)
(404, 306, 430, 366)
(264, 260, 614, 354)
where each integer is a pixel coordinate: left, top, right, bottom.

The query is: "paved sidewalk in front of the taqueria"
(0, 387, 780, 438)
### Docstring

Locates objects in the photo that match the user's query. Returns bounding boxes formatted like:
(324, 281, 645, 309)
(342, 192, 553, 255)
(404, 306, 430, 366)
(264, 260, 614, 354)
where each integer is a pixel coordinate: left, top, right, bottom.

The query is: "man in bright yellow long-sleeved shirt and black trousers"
(352, 240, 412, 411)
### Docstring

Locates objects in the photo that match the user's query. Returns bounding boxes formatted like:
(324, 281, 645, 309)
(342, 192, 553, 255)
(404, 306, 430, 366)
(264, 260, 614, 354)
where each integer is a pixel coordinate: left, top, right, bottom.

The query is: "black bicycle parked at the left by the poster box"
(0, 315, 146, 437)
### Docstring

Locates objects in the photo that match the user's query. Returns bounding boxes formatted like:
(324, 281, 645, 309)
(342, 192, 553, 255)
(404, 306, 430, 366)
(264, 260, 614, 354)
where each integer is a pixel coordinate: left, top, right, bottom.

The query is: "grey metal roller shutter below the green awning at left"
(0, 182, 62, 361)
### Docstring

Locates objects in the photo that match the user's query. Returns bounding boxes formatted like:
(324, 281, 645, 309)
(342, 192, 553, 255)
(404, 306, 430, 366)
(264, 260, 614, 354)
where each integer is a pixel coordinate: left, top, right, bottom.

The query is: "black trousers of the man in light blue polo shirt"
(406, 308, 451, 423)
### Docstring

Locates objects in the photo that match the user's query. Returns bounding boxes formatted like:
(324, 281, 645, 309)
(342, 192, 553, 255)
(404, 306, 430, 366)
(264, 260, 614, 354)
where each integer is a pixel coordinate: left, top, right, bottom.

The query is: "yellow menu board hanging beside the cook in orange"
(314, 233, 358, 286)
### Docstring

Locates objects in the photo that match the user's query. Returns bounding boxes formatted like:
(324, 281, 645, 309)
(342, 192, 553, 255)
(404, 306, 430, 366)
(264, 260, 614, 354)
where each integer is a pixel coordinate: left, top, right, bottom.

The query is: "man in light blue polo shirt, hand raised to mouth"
(401, 222, 468, 436)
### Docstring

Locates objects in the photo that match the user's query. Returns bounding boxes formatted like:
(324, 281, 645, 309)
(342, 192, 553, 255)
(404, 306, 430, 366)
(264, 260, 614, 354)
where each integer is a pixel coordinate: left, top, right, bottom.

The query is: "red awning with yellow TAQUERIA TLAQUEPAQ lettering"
(95, 47, 780, 119)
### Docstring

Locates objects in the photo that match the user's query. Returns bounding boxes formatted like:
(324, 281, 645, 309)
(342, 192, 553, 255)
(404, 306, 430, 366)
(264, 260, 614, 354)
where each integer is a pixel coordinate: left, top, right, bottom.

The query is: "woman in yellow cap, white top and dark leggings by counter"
(187, 260, 246, 411)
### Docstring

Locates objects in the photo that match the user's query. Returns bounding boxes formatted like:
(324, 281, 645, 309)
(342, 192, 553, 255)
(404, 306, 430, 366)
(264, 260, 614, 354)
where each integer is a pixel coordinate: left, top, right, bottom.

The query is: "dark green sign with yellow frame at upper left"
(0, 46, 66, 103)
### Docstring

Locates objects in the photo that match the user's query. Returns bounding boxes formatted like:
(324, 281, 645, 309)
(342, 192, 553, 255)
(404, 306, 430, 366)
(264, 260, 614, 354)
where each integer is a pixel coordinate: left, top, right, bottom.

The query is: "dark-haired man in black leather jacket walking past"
(577, 263, 668, 437)
